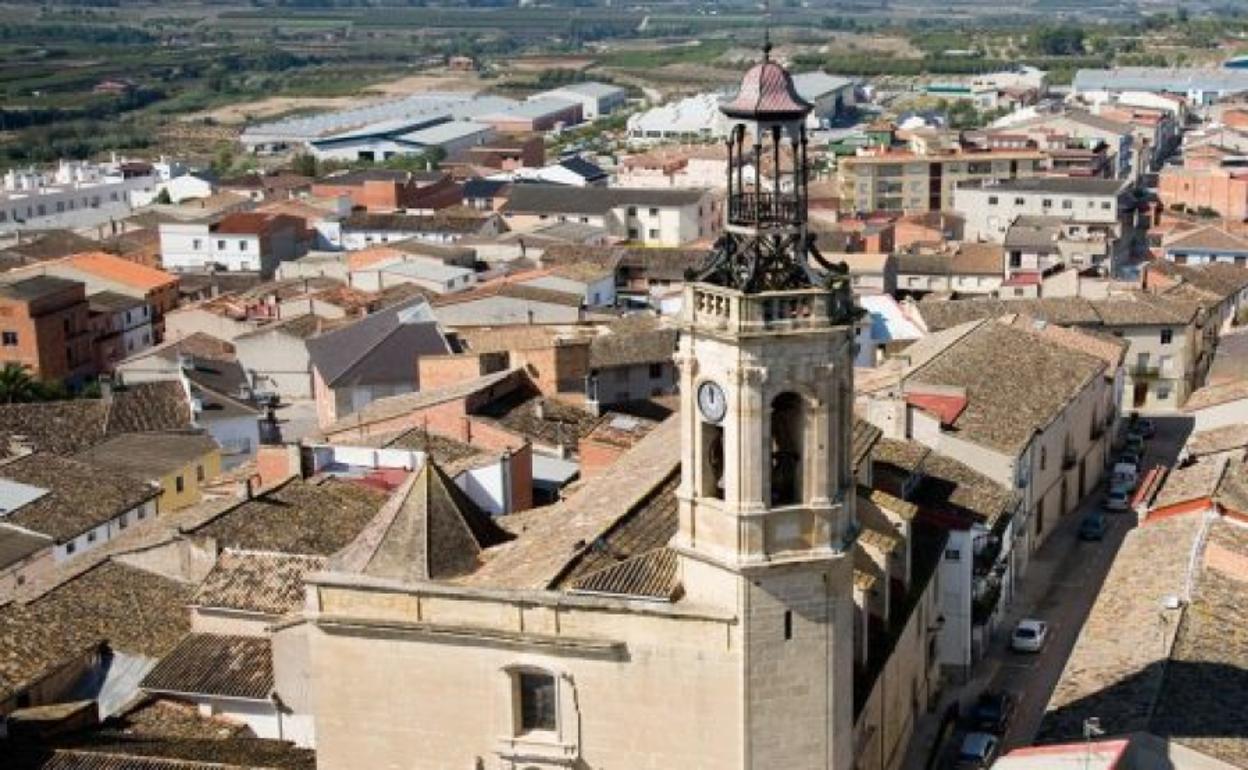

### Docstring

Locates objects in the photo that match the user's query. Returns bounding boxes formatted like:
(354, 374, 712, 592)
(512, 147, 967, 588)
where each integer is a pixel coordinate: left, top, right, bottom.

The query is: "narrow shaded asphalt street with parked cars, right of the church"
(904, 417, 1189, 770)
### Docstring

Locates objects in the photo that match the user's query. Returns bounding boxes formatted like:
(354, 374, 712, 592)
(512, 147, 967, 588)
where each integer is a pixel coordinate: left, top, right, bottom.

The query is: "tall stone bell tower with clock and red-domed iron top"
(673, 38, 857, 770)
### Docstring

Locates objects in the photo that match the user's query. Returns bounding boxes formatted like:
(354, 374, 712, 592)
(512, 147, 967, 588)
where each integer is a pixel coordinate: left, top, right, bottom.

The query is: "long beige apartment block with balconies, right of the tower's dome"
(836, 150, 1046, 213)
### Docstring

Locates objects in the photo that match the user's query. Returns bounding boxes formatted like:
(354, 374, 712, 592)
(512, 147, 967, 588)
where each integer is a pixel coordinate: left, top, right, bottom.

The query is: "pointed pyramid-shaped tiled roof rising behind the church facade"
(329, 461, 509, 582)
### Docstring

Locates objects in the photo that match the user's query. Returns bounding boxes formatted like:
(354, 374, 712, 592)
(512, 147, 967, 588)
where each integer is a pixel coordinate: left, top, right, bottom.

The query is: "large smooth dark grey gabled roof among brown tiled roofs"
(307, 297, 451, 387)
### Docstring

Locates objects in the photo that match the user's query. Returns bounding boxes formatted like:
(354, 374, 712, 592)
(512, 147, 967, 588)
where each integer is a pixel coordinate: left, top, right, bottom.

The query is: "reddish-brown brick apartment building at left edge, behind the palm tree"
(0, 276, 95, 382)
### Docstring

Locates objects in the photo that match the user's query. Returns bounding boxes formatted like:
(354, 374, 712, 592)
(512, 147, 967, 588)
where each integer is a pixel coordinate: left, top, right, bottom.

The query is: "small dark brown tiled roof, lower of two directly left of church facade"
(139, 634, 273, 700)
